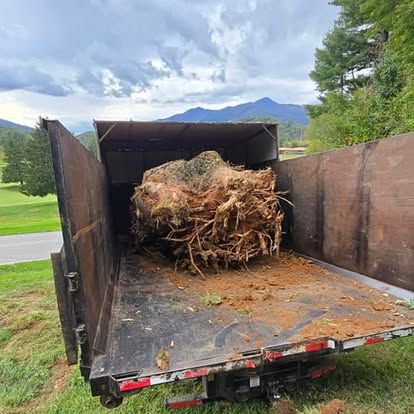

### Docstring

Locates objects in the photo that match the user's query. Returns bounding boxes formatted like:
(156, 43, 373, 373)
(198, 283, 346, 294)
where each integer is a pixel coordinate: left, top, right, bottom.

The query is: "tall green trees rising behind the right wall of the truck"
(305, 0, 414, 152)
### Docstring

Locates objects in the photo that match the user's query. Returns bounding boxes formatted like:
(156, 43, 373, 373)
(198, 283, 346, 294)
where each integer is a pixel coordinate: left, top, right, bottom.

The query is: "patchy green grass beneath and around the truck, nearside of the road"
(0, 260, 414, 414)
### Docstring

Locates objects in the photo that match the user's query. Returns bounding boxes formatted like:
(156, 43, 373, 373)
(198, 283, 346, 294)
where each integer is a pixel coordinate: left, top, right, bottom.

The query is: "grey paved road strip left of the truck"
(0, 231, 63, 264)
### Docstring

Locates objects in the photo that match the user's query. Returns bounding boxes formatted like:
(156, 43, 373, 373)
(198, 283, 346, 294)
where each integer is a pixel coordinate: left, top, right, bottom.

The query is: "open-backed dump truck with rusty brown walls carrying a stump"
(42, 119, 414, 409)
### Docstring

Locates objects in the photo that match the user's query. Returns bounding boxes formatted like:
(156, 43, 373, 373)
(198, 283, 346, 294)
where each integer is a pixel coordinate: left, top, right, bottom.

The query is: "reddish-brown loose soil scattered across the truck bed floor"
(138, 252, 414, 341)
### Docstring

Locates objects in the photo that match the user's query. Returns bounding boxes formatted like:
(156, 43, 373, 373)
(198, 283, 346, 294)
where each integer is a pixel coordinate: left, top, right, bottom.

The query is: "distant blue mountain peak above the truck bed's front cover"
(159, 97, 308, 125)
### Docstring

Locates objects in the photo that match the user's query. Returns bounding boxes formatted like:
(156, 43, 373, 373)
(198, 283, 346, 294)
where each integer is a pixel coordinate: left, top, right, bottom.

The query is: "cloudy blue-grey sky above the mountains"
(0, 0, 337, 131)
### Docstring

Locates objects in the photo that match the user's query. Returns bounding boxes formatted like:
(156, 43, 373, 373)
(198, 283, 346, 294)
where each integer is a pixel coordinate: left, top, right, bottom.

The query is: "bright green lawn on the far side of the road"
(0, 183, 60, 236)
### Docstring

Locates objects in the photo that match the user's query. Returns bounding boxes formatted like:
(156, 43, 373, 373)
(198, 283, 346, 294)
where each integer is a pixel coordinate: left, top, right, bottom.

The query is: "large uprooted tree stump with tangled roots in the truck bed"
(131, 151, 283, 277)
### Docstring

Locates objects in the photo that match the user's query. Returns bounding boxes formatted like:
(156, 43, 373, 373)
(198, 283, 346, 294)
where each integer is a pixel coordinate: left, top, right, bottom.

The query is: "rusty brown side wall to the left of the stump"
(43, 120, 118, 367)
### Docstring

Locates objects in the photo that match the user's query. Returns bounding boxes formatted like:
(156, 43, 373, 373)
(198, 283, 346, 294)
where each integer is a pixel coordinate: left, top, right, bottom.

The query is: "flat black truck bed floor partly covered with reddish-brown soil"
(91, 251, 414, 377)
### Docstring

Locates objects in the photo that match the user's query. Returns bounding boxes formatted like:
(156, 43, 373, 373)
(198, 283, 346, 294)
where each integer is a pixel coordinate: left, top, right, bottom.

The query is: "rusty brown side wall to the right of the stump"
(277, 133, 414, 290)
